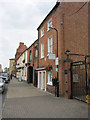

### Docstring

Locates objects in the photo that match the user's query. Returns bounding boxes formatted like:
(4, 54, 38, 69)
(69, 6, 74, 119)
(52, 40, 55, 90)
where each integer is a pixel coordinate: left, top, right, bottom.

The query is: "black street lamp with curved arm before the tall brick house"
(49, 27, 59, 97)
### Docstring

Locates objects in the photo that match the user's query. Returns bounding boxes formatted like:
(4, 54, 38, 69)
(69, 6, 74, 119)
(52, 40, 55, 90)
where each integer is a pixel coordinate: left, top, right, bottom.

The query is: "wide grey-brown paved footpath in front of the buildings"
(2, 78, 88, 118)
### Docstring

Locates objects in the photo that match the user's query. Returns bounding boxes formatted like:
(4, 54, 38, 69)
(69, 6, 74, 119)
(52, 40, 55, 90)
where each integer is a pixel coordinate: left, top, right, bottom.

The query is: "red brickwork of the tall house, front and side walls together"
(38, 3, 90, 95)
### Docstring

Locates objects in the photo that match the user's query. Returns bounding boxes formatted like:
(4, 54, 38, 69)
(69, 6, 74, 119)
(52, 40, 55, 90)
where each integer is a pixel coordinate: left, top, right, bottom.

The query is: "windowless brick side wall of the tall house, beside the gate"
(60, 3, 88, 95)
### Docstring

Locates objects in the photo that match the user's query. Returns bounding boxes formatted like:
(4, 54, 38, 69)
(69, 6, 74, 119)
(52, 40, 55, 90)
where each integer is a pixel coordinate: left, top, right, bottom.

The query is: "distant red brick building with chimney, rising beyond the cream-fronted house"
(15, 42, 27, 75)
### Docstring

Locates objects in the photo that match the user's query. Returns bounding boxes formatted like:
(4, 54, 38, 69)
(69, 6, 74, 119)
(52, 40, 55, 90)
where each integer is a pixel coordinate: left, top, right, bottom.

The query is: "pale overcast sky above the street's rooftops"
(0, 0, 57, 68)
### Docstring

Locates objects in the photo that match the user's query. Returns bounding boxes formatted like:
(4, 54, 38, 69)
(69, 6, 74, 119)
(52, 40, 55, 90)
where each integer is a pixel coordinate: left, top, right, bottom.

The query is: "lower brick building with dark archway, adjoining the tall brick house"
(27, 40, 38, 87)
